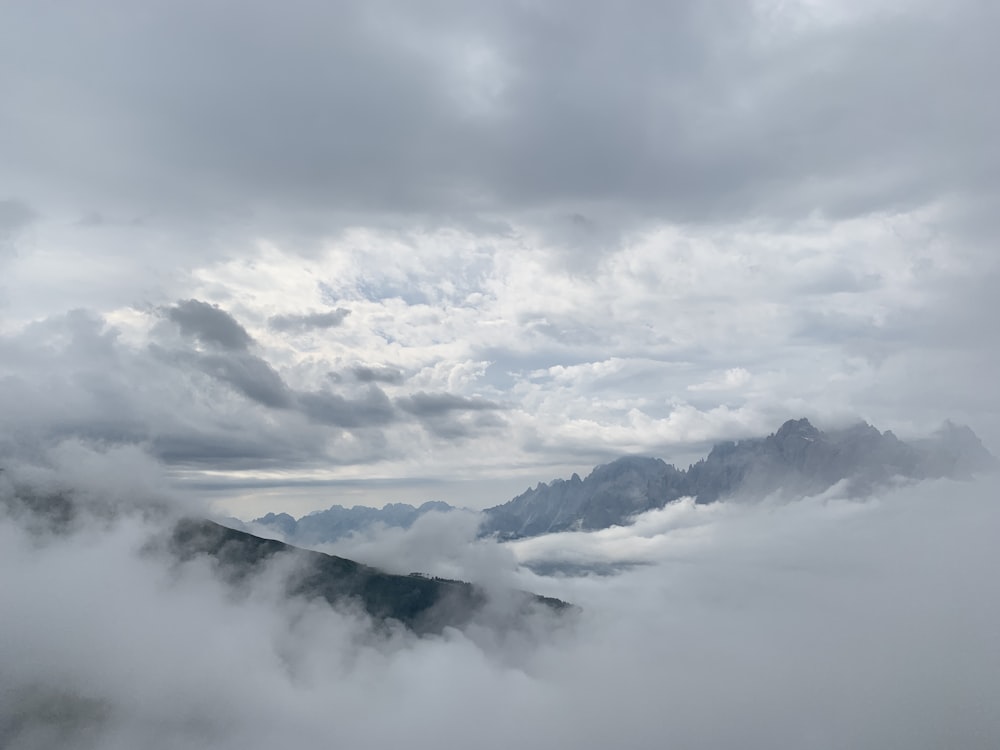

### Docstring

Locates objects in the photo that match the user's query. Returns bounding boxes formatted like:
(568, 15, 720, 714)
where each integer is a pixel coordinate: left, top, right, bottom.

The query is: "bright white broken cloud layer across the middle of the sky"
(5, 203, 995, 510)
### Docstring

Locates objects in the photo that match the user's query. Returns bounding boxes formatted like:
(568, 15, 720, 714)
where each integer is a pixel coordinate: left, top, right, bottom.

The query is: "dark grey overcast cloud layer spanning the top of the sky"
(0, 0, 1000, 232)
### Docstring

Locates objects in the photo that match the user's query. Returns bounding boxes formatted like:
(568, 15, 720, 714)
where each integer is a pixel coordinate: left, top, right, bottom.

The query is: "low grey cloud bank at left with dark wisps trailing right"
(0, 305, 524, 482)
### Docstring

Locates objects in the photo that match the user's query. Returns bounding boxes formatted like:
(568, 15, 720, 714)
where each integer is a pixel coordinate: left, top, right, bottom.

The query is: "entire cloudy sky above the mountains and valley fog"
(0, 0, 1000, 518)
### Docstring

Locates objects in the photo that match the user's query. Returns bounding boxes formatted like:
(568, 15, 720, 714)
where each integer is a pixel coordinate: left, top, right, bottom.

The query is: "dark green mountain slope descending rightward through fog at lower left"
(0, 485, 575, 633)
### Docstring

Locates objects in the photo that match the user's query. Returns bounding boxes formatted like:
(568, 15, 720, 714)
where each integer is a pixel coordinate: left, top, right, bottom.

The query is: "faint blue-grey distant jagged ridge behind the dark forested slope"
(253, 502, 454, 546)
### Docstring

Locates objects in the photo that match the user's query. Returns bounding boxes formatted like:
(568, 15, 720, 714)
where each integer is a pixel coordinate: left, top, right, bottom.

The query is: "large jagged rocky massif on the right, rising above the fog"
(481, 419, 997, 539)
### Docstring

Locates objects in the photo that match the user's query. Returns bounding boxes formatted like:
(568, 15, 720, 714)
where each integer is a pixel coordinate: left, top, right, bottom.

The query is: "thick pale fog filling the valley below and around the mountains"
(0, 445, 1000, 750)
